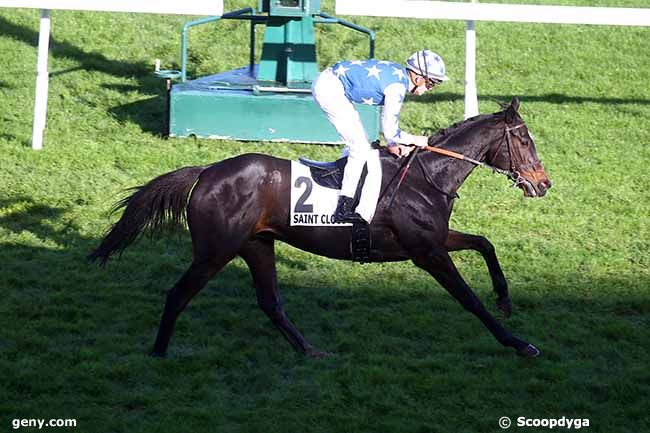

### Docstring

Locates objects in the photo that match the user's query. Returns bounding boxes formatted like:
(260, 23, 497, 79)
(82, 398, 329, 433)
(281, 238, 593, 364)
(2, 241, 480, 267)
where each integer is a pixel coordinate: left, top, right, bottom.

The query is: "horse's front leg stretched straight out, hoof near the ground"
(413, 248, 540, 358)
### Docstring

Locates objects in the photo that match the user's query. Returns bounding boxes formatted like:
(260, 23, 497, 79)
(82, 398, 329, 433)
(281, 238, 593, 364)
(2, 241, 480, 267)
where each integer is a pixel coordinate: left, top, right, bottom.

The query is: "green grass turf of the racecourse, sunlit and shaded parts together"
(0, 0, 650, 432)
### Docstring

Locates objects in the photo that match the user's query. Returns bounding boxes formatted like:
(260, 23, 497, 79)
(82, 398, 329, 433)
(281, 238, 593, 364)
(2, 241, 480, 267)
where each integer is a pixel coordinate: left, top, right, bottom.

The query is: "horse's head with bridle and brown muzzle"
(486, 98, 551, 197)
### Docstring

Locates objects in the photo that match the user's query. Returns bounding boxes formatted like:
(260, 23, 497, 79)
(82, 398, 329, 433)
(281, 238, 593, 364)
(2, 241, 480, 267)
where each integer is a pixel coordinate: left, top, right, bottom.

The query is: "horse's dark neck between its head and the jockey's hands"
(427, 117, 497, 196)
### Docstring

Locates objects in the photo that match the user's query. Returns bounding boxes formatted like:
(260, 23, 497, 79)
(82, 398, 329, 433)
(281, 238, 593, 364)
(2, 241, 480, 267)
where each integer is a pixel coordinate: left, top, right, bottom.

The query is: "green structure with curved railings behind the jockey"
(158, 0, 380, 143)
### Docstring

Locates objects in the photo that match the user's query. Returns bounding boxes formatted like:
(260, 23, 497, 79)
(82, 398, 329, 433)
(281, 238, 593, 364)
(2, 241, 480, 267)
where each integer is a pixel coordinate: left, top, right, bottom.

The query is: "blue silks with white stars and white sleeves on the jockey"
(332, 59, 413, 145)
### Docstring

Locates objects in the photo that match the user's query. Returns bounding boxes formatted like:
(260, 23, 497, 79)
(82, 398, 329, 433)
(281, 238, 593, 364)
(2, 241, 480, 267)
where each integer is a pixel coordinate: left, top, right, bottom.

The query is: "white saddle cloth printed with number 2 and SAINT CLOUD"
(290, 150, 381, 226)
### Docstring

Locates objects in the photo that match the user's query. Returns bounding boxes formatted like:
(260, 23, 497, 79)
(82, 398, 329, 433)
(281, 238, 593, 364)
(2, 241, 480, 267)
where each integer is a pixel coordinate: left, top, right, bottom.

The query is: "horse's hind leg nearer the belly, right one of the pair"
(239, 239, 327, 358)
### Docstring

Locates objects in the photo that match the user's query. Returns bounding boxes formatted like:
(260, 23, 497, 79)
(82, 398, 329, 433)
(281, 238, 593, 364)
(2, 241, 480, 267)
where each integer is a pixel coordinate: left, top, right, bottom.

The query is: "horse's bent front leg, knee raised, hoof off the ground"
(445, 230, 512, 317)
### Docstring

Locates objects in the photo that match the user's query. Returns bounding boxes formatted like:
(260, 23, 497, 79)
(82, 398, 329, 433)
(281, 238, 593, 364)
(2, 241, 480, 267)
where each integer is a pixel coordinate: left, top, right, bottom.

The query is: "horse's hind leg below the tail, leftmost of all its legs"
(151, 256, 234, 357)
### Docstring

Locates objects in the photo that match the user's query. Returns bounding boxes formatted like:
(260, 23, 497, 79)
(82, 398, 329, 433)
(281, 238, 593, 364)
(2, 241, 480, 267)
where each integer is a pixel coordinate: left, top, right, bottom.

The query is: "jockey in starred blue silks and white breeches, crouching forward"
(312, 50, 449, 222)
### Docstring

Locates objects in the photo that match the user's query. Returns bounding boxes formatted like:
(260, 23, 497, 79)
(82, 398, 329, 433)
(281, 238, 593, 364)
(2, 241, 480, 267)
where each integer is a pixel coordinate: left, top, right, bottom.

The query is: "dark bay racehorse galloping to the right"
(90, 98, 551, 357)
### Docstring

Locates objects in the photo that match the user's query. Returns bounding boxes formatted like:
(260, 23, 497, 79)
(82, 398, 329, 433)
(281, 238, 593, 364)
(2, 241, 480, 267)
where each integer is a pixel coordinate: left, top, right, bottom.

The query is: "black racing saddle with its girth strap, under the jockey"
(300, 157, 371, 263)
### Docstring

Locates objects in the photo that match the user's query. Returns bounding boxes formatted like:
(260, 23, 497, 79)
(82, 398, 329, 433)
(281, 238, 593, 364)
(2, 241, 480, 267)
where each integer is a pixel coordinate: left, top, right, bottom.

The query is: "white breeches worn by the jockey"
(312, 68, 372, 197)
